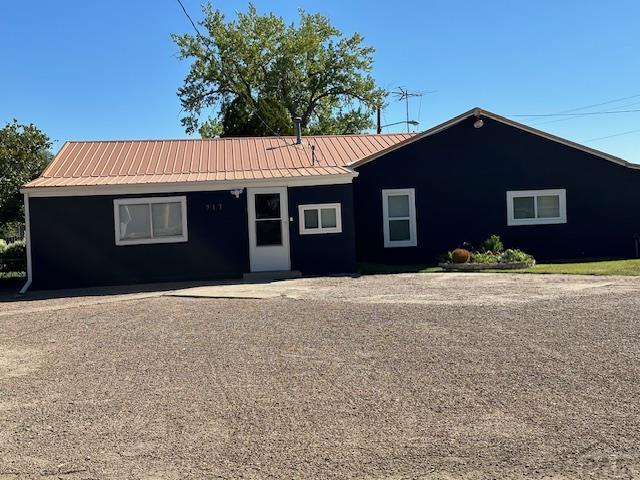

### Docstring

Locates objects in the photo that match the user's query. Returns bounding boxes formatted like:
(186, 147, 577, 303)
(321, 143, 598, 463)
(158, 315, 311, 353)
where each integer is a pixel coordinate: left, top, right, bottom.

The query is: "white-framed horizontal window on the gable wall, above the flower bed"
(507, 189, 567, 225)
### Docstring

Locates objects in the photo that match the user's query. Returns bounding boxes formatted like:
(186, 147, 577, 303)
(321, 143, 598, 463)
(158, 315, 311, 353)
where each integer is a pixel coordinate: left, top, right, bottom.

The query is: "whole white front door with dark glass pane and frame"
(247, 187, 291, 272)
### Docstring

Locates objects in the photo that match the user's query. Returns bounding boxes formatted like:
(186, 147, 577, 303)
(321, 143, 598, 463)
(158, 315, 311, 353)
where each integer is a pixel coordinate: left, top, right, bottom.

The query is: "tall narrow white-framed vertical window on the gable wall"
(382, 188, 418, 248)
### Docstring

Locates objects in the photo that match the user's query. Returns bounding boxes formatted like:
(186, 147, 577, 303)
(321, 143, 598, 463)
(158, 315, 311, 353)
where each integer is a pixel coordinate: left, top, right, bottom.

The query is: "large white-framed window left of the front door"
(113, 196, 188, 245)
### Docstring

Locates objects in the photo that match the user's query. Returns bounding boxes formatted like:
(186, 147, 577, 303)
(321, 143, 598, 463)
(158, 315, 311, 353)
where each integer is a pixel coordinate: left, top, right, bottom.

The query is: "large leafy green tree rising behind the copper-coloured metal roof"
(173, 4, 386, 136)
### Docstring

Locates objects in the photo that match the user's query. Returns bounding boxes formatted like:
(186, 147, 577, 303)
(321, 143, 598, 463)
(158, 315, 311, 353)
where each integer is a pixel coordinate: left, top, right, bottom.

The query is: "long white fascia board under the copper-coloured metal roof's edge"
(20, 172, 358, 197)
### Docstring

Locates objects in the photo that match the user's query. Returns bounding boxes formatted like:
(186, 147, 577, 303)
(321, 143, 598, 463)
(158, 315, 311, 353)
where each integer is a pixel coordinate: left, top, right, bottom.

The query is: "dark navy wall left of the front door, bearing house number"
(29, 190, 249, 288)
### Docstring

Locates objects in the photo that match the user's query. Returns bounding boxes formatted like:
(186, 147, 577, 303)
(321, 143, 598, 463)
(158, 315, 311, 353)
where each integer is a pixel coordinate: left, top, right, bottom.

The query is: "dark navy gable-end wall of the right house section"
(354, 118, 640, 263)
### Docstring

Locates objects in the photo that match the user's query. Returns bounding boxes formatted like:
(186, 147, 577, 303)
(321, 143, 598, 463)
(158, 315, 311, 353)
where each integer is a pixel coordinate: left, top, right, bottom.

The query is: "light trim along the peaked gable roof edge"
(347, 107, 640, 169)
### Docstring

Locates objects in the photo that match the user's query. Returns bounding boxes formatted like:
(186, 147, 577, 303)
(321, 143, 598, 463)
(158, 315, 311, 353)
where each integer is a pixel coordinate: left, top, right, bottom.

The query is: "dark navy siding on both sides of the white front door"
(29, 184, 356, 288)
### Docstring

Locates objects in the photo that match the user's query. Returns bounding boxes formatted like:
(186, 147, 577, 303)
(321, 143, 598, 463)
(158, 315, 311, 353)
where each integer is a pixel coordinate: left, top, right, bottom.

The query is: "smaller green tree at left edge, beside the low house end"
(0, 120, 52, 223)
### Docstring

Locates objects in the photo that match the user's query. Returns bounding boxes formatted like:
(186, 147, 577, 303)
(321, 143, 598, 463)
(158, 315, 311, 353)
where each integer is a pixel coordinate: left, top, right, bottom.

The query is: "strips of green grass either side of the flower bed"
(360, 259, 640, 275)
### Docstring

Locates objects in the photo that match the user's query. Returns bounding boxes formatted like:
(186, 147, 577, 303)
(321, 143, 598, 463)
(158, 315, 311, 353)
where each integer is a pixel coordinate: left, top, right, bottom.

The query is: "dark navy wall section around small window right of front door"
(289, 184, 356, 275)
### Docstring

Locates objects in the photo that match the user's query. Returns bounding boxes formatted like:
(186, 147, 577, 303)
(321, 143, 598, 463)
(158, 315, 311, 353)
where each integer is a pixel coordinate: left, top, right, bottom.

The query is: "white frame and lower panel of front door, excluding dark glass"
(247, 187, 291, 272)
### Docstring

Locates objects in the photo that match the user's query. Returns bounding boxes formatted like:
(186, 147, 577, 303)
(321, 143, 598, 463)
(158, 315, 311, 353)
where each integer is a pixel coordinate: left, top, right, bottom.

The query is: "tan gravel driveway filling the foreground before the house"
(0, 274, 640, 480)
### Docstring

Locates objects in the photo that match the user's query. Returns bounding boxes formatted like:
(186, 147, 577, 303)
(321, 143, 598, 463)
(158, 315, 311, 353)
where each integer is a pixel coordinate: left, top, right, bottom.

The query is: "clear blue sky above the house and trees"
(0, 0, 640, 163)
